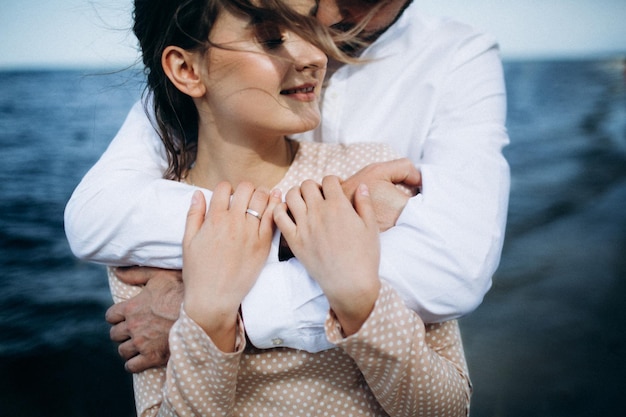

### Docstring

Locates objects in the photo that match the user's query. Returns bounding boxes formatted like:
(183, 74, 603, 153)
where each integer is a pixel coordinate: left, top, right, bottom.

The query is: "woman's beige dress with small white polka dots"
(109, 142, 471, 417)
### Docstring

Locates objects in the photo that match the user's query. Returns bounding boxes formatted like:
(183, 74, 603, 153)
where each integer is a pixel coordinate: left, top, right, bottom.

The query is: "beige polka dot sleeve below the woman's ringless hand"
(326, 282, 472, 417)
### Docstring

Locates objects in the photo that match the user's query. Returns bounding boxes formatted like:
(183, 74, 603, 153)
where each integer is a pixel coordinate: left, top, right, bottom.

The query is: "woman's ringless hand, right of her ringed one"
(274, 176, 380, 336)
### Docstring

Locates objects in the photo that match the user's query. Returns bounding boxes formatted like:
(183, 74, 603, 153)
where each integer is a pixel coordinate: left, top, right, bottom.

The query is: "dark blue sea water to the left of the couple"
(0, 72, 140, 417)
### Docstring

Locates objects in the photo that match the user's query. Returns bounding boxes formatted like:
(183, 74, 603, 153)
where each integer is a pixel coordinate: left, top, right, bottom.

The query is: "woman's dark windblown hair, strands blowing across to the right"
(133, 0, 354, 180)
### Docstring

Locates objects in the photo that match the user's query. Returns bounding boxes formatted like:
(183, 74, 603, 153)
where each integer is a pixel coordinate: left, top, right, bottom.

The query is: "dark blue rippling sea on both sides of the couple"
(0, 60, 626, 417)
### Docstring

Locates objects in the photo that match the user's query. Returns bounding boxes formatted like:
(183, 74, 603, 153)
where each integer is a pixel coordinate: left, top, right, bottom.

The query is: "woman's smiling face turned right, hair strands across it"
(198, 0, 327, 140)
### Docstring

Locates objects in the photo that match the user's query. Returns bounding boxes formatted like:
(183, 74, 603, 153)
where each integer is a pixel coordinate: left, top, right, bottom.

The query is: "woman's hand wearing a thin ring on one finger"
(183, 183, 280, 351)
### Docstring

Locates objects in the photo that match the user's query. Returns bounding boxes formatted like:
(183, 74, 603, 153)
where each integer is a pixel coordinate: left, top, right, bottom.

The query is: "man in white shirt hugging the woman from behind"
(66, 0, 509, 372)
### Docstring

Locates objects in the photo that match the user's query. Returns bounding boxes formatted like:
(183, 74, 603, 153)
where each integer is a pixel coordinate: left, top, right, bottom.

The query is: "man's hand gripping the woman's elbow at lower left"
(106, 267, 183, 373)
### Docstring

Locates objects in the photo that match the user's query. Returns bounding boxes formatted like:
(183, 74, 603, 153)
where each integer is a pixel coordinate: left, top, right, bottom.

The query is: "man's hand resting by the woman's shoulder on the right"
(341, 158, 422, 232)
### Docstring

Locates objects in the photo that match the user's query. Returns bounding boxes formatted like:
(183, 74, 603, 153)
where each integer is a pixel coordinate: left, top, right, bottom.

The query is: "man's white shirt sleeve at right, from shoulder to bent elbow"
(380, 35, 510, 323)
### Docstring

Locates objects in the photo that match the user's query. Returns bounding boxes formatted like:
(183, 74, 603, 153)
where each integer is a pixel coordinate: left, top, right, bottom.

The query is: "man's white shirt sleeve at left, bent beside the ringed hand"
(65, 103, 210, 269)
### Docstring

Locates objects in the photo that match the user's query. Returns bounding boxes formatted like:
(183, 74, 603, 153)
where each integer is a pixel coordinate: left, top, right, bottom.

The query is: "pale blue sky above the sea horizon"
(0, 0, 626, 68)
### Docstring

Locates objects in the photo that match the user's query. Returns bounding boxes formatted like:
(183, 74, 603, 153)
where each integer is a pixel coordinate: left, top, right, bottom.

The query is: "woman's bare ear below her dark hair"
(161, 46, 206, 98)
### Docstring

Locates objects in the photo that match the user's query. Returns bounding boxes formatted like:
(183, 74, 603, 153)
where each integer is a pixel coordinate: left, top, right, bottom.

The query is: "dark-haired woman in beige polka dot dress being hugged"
(101, 0, 471, 416)
